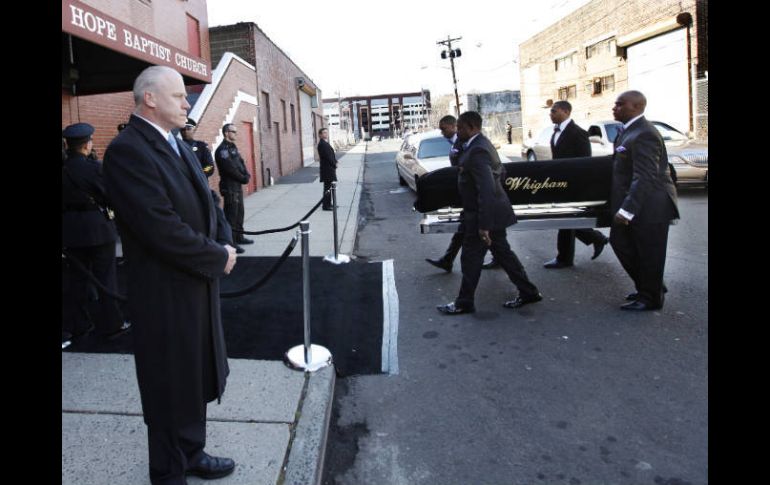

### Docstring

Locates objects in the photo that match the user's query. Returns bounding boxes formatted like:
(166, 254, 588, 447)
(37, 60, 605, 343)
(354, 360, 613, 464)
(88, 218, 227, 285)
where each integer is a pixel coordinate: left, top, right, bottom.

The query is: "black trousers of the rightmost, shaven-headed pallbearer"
(610, 221, 669, 306)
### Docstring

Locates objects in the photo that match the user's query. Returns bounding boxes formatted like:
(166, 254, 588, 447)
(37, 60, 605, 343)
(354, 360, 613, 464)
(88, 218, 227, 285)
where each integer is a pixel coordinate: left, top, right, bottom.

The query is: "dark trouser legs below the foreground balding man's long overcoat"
(147, 420, 206, 485)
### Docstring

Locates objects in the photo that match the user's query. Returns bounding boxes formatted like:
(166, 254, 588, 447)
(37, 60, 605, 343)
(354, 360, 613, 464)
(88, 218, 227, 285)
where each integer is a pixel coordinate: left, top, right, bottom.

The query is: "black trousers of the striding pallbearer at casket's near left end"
(455, 229, 538, 307)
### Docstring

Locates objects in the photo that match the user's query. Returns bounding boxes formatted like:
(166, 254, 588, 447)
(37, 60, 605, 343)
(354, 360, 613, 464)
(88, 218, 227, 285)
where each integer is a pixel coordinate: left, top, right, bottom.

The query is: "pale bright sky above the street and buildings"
(207, 0, 589, 98)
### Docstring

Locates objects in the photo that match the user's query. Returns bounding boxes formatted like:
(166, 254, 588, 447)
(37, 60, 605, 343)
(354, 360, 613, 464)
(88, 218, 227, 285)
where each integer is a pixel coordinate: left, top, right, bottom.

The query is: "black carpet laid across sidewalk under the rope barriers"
(64, 257, 384, 376)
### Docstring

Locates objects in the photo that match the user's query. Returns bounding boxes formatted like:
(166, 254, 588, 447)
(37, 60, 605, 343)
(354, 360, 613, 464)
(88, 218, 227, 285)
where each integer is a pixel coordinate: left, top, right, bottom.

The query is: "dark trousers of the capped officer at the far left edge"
(62, 242, 123, 335)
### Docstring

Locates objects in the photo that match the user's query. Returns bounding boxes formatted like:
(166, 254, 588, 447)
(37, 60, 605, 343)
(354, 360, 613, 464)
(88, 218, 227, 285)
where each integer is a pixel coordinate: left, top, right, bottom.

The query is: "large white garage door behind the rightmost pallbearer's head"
(627, 29, 690, 132)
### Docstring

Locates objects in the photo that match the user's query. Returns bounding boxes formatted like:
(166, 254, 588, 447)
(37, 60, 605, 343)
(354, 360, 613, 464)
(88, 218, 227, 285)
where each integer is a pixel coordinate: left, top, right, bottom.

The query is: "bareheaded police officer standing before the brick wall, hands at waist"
(214, 123, 254, 254)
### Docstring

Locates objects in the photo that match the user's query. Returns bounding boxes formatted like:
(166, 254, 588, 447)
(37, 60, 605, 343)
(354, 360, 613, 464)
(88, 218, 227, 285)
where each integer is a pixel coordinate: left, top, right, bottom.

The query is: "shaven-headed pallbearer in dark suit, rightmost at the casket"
(610, 91, 679, 310)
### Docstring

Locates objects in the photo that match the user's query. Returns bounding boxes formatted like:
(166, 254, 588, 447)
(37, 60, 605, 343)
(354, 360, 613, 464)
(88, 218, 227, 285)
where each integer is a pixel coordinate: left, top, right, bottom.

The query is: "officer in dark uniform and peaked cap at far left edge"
(62, 123, 131, 340)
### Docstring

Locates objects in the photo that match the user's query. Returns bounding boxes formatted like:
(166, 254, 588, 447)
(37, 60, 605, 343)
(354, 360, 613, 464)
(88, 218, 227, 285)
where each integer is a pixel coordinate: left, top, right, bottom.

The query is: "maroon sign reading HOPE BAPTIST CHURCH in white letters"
(62, 0, 211, 82)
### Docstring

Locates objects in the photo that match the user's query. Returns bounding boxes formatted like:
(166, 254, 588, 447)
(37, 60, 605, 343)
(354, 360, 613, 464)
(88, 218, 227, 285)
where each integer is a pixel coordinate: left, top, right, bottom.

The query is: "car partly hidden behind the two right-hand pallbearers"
(521, 120, 708, 188)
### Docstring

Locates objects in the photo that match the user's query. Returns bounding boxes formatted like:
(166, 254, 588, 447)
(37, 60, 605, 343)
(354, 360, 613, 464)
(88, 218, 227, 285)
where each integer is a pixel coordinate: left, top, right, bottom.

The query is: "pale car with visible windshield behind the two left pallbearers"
(396, 130, 452, 191)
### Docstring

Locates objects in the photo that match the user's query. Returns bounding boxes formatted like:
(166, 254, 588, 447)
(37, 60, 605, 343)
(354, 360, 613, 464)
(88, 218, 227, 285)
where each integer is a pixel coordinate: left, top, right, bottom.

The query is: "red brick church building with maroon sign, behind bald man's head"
(61, 0, 211, 155)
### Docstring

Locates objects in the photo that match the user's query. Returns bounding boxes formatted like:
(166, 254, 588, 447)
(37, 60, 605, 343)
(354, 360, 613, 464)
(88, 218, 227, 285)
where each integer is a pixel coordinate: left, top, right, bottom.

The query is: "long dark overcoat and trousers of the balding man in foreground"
(104, 115, 229, 484)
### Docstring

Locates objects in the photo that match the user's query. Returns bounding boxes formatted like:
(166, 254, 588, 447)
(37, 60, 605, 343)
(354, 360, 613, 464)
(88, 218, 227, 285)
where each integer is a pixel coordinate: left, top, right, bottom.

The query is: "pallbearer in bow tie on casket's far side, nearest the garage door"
(543, 101, 609, 269)
